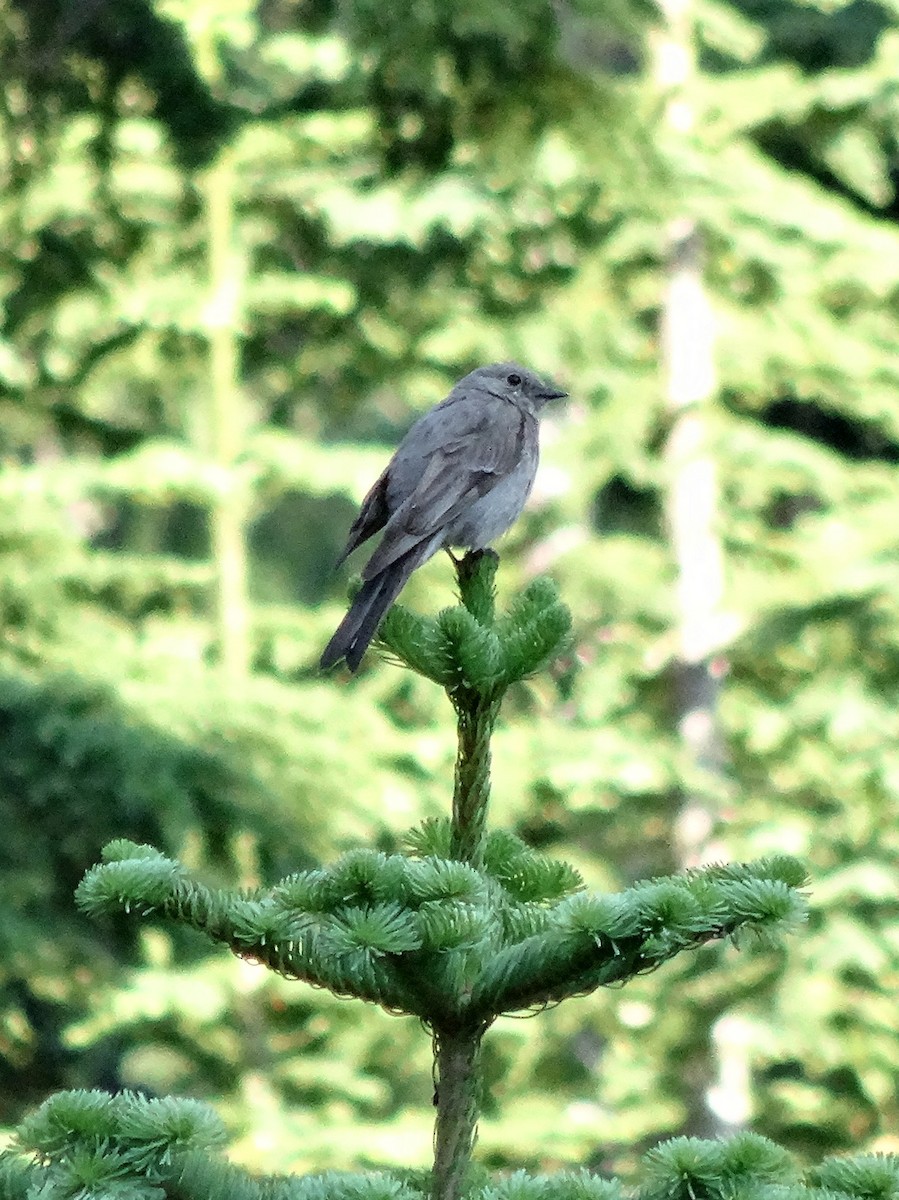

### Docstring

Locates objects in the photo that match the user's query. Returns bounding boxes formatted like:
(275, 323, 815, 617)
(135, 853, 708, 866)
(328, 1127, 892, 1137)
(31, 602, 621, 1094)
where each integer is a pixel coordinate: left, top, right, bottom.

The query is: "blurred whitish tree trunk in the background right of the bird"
(655, 0, 751, 1136)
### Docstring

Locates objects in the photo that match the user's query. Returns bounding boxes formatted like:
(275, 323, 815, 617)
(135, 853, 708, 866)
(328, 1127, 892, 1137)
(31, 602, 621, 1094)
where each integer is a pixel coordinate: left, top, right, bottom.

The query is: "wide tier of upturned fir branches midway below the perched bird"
(77, 840, 803, 1024)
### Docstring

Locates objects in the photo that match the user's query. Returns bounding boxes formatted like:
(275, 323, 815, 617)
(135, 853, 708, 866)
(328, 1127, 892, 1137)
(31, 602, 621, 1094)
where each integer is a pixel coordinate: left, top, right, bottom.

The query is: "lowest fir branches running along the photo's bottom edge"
(0, 1091, 899, 1200)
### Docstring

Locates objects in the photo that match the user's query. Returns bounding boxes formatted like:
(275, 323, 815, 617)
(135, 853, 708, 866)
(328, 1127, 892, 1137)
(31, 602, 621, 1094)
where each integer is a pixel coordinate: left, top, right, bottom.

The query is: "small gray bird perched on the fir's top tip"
(322, 362, 567, 671)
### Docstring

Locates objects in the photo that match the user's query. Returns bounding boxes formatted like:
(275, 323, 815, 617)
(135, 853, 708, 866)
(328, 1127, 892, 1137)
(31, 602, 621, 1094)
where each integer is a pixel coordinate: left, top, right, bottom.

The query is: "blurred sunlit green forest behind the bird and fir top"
(0, 0, 899, 1174)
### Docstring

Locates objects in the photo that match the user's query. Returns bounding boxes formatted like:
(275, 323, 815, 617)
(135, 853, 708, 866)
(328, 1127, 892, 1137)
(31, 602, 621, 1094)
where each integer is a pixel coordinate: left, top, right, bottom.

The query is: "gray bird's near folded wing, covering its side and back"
(362, 398, 526, 580)
